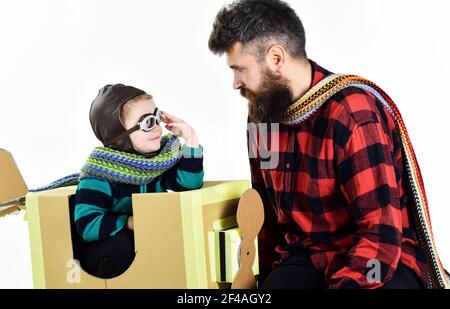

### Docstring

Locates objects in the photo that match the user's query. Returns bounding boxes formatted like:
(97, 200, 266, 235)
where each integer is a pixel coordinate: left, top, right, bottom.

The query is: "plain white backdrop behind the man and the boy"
(0, 0, 450, 288)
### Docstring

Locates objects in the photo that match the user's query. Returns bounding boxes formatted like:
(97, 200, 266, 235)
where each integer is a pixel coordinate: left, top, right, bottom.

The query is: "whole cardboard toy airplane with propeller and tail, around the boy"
(0, 150, 264, 288)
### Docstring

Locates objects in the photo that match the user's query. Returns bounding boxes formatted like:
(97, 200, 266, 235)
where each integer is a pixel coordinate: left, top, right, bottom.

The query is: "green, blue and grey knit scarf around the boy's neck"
(30, 133, 181, 192)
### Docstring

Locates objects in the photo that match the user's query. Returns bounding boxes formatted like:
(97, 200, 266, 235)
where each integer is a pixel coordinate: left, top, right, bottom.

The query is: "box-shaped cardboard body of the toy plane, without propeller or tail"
(26, 180, 256, 288)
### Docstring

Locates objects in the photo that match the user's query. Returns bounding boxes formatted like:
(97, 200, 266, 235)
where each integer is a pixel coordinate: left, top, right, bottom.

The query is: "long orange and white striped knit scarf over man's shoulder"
(284, 74, 450, 288)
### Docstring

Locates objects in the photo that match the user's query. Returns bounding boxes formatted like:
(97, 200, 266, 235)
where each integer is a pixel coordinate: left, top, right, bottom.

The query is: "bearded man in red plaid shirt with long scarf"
(209, 0, 449, 288)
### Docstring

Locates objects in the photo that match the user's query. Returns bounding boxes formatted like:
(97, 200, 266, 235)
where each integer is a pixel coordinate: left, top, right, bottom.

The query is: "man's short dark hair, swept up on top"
(208, 0, 306, 59)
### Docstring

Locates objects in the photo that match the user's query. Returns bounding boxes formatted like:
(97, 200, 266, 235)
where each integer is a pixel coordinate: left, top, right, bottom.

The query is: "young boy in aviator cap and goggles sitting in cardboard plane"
(74, 84, 203, 278)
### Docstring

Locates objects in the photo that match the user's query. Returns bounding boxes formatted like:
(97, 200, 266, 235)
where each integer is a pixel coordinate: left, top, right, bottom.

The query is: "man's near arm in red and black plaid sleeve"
(329, 106, 402, 288)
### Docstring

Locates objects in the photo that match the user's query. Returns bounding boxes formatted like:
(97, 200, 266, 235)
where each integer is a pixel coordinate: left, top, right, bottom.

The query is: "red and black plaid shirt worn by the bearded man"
(248, 61, 428, 288)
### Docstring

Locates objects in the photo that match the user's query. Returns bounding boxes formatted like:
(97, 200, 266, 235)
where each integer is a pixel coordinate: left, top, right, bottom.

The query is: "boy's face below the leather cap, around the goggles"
(123, 99, 162, 153)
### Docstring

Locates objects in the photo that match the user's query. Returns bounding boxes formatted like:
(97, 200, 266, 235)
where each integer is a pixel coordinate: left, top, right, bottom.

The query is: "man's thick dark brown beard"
(240, 69, 293, 123)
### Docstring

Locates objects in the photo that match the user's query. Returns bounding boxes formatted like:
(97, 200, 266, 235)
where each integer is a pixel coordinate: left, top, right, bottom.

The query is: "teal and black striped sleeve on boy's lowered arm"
(74, 178, 128, 242)
